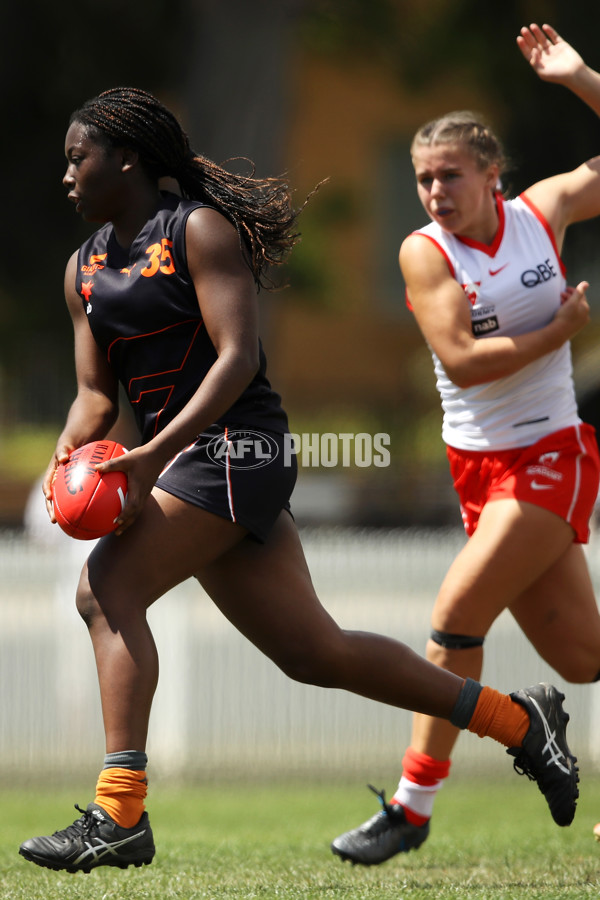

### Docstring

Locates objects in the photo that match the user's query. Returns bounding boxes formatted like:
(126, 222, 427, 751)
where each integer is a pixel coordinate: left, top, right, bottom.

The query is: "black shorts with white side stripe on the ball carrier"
(156, 425, 298, 543)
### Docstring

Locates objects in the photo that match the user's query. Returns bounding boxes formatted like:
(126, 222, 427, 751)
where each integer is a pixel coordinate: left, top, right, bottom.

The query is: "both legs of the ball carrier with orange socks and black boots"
(21, 502, 577, 871)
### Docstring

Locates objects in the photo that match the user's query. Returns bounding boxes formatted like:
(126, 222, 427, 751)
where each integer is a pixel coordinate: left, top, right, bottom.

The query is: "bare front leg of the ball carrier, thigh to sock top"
(77, 489, 245, 753)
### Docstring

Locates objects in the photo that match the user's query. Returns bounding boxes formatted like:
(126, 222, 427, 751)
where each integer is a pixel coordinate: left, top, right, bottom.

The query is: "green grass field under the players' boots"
(0, 776, 600, 900)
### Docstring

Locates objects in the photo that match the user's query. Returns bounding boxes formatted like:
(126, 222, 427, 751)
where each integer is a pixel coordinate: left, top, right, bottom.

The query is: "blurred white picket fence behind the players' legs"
(0, 529, 600, 781)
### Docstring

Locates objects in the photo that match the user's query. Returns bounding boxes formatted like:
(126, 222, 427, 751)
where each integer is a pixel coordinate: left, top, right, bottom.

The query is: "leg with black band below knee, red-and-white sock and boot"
(332, 500, 573, 864)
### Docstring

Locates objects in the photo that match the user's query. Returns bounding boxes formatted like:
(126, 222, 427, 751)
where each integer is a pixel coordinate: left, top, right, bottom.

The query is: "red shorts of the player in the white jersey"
(446, 423, 600, 544)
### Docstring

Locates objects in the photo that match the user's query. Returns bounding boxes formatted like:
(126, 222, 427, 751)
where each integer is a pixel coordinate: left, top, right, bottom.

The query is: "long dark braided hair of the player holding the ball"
(69, 88, 302, 288)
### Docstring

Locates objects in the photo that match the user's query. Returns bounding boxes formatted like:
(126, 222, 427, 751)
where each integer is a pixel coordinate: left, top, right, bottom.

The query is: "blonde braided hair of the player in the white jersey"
(410, 110, 508, 175)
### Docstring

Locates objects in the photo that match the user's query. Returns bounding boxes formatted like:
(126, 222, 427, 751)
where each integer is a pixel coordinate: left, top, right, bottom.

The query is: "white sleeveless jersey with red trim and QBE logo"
(415, 194, 581, 450)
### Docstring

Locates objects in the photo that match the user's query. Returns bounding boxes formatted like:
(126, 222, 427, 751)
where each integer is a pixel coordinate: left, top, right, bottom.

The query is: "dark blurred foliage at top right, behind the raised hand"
(302, 0, 600, 277)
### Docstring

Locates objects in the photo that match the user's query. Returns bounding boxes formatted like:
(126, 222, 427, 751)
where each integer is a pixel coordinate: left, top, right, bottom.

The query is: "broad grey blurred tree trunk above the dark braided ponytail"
(182, 0, 308, 176)
